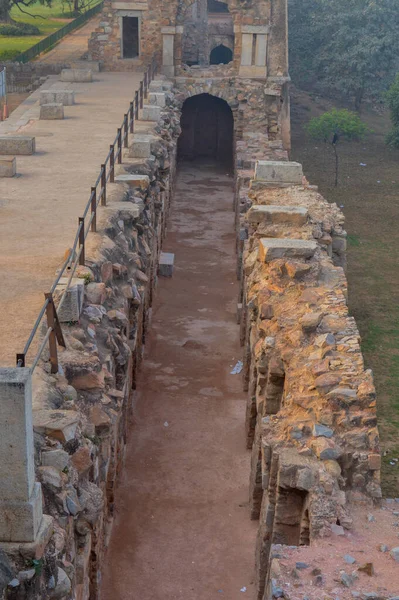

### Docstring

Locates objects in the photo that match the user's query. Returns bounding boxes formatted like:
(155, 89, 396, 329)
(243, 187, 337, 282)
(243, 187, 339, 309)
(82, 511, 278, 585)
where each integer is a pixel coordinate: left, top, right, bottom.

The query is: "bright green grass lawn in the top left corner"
(0, 0, 98, 60)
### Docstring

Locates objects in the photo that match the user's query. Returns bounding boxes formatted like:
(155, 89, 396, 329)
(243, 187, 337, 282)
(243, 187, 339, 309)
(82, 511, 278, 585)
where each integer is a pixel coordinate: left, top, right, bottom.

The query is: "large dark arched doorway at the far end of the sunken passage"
(178, 94, 234, 167)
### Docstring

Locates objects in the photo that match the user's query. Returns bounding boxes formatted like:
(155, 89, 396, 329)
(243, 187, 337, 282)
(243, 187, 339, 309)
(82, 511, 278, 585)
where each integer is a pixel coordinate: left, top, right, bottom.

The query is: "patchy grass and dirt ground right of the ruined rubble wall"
(291, 85, 399, 497)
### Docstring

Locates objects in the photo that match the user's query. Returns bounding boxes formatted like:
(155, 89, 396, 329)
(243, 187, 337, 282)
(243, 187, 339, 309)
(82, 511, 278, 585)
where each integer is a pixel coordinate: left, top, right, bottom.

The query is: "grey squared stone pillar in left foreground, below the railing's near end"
(0, 368, 43, 542)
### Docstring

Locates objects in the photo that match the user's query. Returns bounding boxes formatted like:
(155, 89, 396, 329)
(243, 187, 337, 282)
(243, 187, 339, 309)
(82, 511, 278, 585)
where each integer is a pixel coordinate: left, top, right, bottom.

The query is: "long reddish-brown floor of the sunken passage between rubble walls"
(102, 163, 257, 600)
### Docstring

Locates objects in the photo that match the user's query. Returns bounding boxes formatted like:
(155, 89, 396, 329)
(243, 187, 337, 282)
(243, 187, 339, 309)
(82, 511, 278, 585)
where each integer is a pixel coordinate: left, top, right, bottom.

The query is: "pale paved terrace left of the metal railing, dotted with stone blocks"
(0, 73, 142, 366)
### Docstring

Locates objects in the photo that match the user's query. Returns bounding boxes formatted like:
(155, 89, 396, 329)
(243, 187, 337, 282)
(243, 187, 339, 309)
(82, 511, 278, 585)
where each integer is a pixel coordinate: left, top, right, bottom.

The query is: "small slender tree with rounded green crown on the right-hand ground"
(305, 108, 369, 186)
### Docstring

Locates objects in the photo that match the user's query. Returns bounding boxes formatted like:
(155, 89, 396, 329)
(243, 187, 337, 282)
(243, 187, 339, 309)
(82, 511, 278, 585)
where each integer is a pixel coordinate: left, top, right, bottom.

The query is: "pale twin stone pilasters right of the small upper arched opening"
(239, 25, 270, 78)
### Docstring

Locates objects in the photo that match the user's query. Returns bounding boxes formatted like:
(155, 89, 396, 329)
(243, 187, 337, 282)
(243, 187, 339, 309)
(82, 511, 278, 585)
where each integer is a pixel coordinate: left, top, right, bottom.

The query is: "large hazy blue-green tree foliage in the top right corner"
(288, 0, 399, 110)
